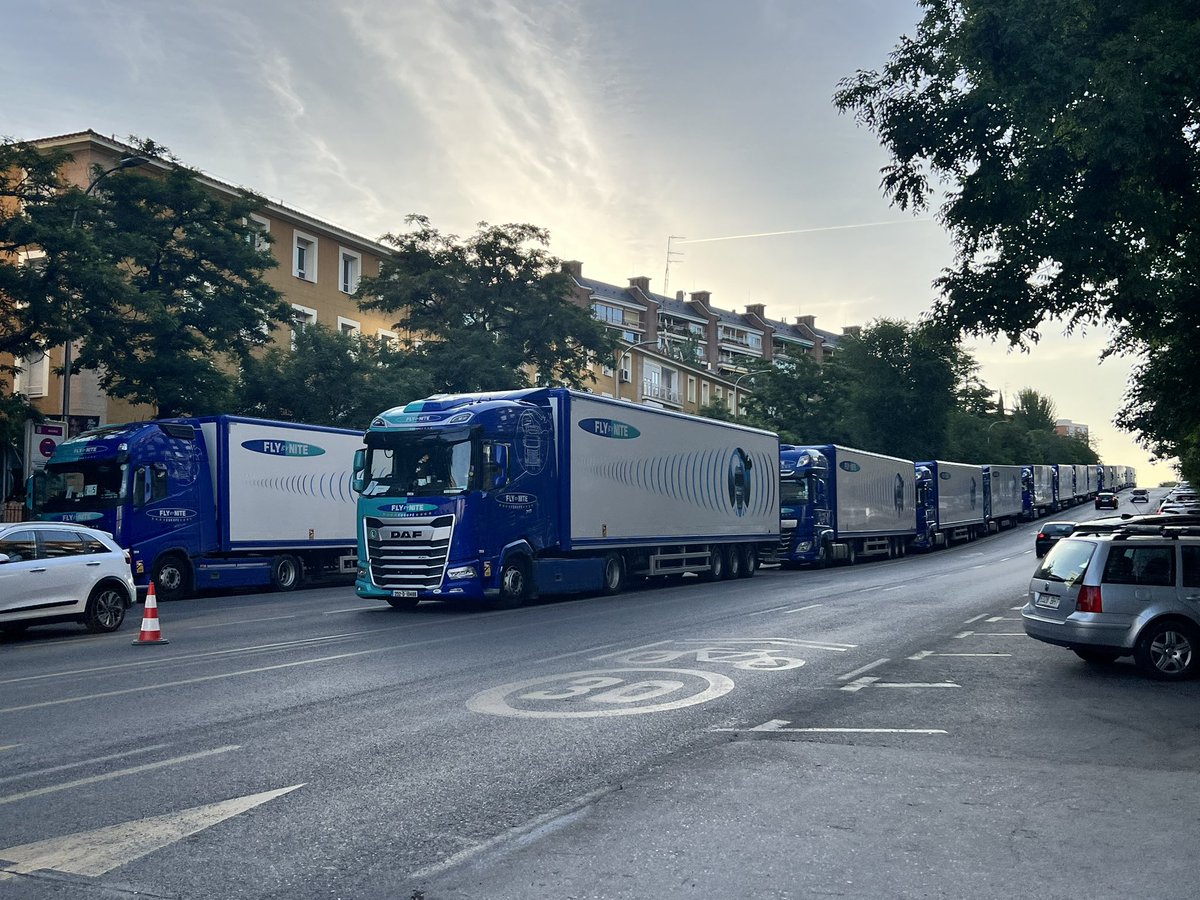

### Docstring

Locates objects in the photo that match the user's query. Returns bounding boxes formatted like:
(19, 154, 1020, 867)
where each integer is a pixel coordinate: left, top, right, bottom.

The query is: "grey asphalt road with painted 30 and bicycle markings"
(0, 494, 1200, 900)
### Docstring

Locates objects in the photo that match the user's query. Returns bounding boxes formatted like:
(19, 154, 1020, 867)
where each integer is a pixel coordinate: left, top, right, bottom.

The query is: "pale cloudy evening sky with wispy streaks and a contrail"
(0, 0, 1170, 484)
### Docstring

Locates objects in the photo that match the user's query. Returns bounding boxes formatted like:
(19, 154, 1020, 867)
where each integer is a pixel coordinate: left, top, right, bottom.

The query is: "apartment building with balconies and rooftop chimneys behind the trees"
(563, 260, 850, 413)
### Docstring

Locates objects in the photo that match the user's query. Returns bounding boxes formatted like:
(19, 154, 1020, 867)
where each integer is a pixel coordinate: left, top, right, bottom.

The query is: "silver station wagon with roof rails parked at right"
(1021, 520, 1200, 680)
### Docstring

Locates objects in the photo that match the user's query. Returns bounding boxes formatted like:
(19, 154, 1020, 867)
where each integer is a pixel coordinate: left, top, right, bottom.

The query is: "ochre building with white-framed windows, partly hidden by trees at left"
(14, 131, 396, 434)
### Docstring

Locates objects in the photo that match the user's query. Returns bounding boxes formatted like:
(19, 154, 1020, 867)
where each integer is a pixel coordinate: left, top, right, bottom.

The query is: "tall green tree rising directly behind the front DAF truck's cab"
(359, 216, 616, 391)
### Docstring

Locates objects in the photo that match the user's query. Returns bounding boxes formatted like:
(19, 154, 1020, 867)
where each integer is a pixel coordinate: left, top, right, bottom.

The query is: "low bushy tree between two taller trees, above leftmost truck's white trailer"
(235, 324, 432, 431)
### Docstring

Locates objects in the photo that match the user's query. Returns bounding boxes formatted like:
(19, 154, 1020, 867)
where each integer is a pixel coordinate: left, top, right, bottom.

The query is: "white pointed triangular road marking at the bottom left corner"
(0, 784, 304, 881)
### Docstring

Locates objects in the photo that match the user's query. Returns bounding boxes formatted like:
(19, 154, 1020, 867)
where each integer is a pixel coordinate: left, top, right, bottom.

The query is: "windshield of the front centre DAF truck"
(362, 432, 478, 497)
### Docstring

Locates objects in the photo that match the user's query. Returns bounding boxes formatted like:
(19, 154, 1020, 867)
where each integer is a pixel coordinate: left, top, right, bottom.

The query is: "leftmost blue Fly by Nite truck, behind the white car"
(29, 415, 362, 600)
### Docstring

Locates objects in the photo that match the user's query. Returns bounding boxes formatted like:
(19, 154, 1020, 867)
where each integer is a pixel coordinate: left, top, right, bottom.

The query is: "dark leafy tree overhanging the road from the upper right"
(834, 0, 1200, 472)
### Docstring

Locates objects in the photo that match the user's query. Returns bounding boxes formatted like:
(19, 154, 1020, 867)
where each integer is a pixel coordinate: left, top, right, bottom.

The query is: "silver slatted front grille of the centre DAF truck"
(364, 516, 454, 590)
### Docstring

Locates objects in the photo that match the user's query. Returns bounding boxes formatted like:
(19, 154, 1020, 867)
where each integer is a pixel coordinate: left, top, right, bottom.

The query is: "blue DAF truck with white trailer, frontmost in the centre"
(354, 388, 779, 608)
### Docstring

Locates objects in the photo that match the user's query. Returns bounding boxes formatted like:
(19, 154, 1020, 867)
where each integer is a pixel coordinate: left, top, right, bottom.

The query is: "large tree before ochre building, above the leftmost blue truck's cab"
(70, 142, 290, 416)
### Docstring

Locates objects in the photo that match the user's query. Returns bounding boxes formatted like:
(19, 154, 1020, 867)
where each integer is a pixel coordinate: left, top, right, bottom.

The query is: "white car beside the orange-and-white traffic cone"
(0, 522, 137, 634)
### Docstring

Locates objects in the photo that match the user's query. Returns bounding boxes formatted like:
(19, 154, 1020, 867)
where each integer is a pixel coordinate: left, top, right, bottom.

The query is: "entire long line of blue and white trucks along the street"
(29, 388, 1135, 607)
